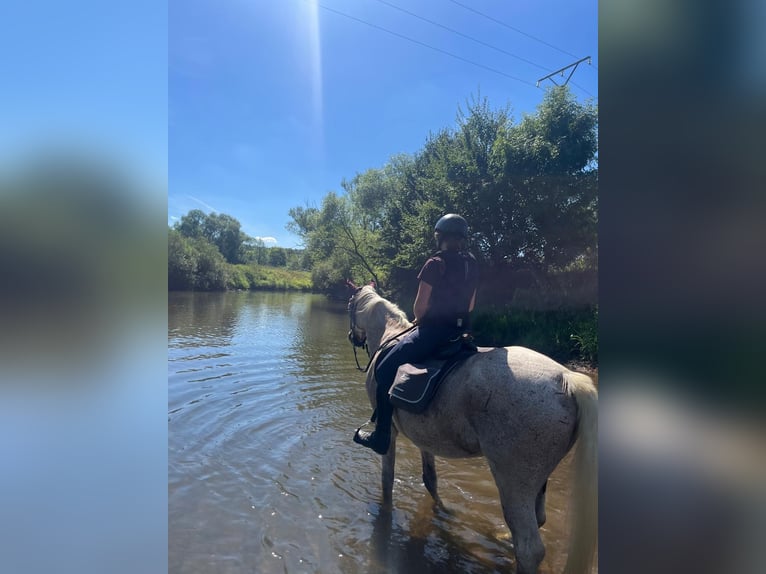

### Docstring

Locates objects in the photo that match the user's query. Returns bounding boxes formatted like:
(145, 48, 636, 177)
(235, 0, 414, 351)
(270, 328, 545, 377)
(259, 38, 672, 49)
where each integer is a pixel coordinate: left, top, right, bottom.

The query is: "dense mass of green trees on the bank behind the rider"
(289, 87, 598, 300)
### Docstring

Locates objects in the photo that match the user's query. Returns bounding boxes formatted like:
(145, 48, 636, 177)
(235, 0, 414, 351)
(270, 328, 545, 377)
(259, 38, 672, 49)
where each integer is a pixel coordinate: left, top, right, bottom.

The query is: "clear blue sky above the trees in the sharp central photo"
(167, 0, 598, 247)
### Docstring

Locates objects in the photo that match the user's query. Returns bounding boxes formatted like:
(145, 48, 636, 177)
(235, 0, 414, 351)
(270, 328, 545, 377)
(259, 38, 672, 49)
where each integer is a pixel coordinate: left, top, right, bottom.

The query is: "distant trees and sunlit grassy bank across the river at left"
(168, 209, 311, 291)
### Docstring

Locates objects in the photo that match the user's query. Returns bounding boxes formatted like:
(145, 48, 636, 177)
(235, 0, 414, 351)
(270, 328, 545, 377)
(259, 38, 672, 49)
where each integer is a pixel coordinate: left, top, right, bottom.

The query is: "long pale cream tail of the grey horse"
(564, 372, 598, 574)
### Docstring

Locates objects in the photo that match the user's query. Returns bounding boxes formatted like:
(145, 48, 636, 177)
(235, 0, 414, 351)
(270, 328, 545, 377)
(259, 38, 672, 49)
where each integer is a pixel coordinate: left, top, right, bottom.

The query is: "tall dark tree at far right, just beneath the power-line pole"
(499, 87, 598, 270)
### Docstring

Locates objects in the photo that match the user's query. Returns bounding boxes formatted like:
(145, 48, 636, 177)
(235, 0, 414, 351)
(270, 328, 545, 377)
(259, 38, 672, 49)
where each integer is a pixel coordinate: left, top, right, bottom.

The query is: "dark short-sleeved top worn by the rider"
(418, 251, 479, 329)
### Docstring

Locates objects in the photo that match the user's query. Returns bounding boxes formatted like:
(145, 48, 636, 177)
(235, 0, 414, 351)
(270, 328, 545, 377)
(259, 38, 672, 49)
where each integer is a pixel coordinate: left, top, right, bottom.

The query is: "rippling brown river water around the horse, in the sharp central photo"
(168, 292, 588, 574)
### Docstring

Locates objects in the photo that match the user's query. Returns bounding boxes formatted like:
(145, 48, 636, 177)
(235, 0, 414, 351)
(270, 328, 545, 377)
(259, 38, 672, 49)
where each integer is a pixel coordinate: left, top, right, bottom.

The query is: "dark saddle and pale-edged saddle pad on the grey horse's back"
(388, 333, 478, 413)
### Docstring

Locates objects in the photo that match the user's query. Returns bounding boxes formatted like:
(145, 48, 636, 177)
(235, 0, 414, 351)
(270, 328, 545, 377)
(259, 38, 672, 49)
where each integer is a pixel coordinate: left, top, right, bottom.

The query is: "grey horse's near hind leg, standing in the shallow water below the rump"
(490, 468, 545, 574)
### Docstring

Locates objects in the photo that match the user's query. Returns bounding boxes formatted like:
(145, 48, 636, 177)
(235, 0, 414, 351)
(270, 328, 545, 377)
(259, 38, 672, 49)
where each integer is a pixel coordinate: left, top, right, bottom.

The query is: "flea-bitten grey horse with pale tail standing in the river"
(349, 285, 597, 574)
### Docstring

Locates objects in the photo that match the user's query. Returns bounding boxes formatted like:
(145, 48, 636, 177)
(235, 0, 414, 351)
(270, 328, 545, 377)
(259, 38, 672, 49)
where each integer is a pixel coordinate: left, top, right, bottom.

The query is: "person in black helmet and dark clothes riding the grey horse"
(354, 213, 478, 454)
